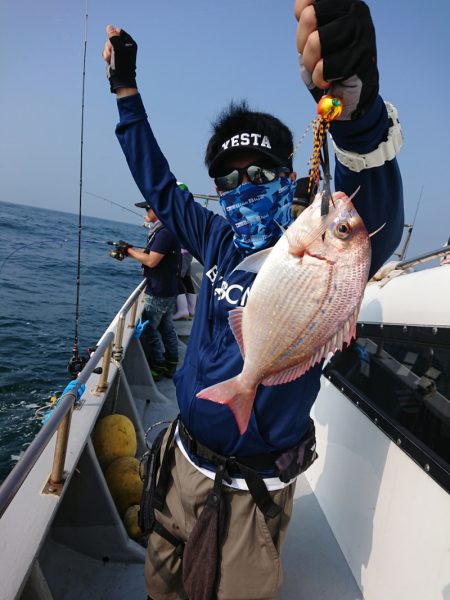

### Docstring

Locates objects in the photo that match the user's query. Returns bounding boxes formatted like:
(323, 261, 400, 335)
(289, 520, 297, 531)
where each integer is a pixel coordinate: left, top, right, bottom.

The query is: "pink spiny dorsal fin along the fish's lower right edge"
(261, 305, 359, 386)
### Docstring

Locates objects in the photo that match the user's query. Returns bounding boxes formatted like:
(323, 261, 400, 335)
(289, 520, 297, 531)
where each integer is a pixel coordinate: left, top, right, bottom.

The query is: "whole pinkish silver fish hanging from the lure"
(197, 192, 371, 434)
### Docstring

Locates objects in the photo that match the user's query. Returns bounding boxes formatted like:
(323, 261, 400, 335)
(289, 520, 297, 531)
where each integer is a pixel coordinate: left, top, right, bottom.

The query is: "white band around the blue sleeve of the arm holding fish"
(332, 102, 403, 173)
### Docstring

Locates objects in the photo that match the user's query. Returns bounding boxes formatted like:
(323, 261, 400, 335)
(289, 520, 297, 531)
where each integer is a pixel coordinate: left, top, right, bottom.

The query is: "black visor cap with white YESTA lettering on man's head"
(208, 131, 292, 177)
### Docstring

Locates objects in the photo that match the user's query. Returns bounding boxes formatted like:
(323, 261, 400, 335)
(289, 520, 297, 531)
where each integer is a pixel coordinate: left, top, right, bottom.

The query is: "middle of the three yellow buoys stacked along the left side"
(105, 456, 143, 517)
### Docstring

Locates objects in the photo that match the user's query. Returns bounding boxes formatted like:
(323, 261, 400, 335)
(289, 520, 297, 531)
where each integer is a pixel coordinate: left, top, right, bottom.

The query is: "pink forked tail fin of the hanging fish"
(197, 375, 256, 435)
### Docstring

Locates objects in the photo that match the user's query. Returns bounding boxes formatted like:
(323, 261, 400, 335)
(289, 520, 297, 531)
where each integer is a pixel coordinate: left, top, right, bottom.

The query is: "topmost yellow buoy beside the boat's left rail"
(93, 415, 137, 469)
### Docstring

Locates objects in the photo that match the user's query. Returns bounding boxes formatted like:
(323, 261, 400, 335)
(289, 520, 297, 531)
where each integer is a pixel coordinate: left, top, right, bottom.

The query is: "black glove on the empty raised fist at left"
(107, 29, 137, 94)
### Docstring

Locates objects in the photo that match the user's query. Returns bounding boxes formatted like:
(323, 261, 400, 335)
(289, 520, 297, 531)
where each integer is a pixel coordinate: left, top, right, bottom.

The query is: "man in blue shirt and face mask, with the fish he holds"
(104, 0, 403, 600)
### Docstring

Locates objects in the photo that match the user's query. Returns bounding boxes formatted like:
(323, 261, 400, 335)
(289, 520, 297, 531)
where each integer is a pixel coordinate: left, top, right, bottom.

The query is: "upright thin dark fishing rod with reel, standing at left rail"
(67, 0, 88, 379)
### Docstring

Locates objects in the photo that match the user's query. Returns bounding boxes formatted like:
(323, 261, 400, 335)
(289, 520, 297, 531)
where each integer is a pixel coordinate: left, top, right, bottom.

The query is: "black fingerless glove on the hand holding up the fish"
(302, 0, 378, 120)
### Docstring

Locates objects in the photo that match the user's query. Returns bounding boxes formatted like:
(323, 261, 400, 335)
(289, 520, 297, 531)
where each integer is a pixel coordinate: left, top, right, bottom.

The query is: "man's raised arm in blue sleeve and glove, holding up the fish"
(294, 0, 404, 273)
